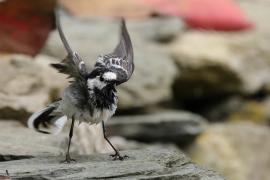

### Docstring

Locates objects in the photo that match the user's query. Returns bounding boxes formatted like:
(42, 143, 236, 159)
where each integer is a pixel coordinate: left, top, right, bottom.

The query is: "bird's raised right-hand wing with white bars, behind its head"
(95, 19, 134, 85)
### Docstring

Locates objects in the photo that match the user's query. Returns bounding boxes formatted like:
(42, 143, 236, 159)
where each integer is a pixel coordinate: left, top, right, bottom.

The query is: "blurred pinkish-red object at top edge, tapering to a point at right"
(139, 0, 254, 31)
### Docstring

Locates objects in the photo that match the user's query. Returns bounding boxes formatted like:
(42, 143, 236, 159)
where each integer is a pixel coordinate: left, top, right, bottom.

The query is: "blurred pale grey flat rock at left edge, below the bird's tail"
(0, 120, 66, 157)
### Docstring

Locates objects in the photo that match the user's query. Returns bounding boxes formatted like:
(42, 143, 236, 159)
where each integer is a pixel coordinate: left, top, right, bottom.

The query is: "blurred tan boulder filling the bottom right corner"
(189, 123, 270, 180)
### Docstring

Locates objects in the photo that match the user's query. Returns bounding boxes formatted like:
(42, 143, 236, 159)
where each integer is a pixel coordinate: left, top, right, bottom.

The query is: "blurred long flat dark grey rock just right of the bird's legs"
(107, 111, 206, 144)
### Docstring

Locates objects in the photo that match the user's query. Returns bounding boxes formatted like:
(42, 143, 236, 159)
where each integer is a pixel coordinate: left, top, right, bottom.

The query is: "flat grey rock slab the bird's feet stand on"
(0, 146, 223, 180)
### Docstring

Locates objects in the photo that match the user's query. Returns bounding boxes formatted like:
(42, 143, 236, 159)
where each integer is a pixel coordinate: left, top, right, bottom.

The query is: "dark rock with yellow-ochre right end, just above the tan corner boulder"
(193, 94, 270, 125)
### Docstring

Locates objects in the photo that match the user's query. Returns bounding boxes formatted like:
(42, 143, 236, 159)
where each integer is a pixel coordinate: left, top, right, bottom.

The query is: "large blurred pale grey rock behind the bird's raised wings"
(43, 15, 176, 109)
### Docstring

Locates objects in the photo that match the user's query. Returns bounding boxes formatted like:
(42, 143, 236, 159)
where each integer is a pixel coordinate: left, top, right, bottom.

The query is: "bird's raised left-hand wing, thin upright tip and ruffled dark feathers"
(51, 12, 88, 80)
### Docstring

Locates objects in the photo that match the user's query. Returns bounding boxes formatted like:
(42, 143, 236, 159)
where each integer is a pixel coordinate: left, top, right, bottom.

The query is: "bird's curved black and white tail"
(27, 104, 67, 134)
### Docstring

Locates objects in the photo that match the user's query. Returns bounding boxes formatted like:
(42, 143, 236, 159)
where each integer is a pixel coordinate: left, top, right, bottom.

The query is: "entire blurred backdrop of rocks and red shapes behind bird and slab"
(0, 0, 270, 180)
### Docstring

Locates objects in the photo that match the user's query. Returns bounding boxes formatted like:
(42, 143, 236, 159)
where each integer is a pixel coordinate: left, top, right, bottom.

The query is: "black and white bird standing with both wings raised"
(27, 14, 135, 163)
